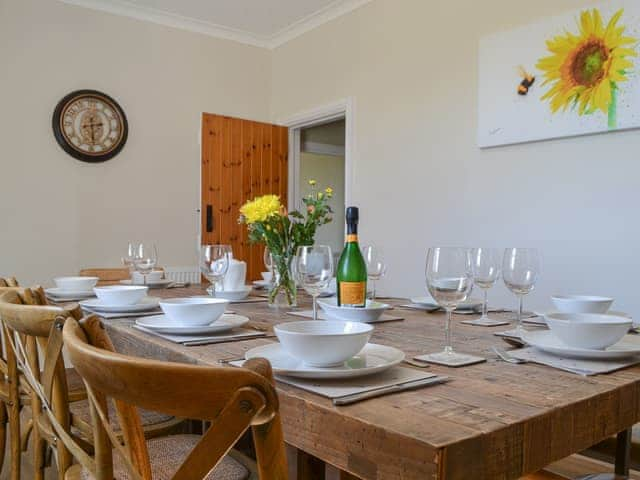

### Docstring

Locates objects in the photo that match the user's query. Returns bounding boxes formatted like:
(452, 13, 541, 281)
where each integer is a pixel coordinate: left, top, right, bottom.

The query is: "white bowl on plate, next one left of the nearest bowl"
(160, 297, 229, 327)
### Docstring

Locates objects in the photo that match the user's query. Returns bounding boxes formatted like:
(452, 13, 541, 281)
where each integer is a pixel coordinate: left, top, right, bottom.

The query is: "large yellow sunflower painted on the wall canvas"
(537, 8, 637, 127)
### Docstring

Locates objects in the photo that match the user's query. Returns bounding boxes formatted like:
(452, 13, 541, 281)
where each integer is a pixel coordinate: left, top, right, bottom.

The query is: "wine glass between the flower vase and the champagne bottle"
(296, 245, 333, 320)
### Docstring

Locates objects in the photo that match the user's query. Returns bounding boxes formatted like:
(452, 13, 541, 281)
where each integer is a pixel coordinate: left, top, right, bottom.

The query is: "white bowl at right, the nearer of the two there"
(544, 313, 633, 350)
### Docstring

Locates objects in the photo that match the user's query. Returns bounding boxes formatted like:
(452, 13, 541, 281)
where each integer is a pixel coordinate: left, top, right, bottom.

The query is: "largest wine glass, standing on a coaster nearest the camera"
(425, 247, 473, 364)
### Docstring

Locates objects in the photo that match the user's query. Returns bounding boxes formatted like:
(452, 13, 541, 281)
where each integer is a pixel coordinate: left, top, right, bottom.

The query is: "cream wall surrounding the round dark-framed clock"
(0, 0, 270, 283)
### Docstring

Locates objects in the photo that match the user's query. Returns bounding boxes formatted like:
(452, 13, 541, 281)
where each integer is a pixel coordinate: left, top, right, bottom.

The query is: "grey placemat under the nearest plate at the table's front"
(229, 361, 449, 405)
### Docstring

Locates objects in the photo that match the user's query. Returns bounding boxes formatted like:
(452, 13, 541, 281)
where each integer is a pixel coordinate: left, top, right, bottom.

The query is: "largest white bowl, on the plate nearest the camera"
(273, 320, 373, 367)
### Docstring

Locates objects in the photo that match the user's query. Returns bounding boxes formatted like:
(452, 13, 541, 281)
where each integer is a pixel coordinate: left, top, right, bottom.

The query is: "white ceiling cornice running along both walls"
(60, 0, 371, 49)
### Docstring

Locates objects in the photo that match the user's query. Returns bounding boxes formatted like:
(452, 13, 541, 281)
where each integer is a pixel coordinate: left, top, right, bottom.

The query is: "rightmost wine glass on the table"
(502, 248, 541, 335)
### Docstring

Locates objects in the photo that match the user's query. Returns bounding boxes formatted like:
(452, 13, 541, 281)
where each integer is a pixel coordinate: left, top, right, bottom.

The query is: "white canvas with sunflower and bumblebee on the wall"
(478, 0, 640, 147)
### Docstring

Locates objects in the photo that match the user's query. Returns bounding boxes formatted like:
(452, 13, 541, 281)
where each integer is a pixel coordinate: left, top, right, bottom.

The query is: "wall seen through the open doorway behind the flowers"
(300, 152, 345, 253)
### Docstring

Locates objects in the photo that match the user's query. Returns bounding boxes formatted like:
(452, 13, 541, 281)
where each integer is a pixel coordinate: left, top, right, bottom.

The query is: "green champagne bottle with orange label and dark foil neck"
(336, 207, 367, 307)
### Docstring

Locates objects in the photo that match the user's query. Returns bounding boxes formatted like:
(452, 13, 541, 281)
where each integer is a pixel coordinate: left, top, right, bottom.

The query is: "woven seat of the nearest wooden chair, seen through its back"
(72, 435, 249, 480)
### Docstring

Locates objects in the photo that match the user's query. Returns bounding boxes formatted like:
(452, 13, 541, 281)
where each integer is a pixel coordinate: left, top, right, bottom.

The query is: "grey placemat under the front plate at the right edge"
(508, 347, 640, 376)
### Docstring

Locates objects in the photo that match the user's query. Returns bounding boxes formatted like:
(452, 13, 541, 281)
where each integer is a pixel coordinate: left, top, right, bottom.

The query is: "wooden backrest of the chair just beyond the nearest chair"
(0, 287, 82, 472)
